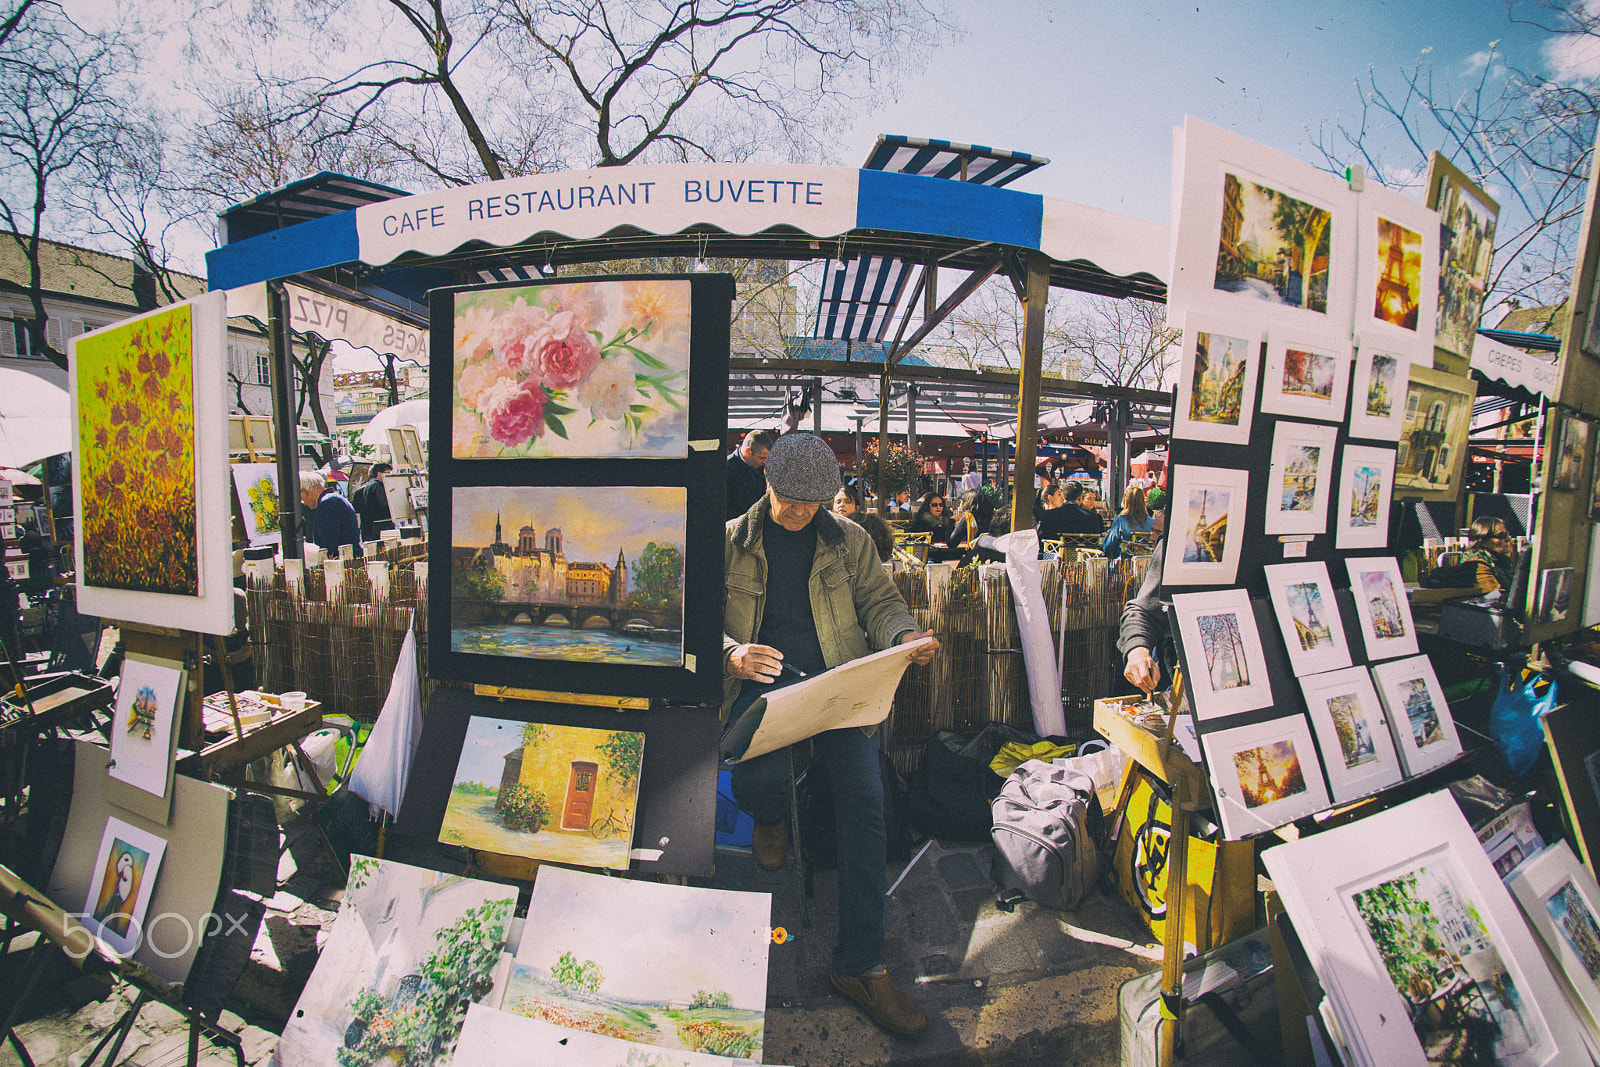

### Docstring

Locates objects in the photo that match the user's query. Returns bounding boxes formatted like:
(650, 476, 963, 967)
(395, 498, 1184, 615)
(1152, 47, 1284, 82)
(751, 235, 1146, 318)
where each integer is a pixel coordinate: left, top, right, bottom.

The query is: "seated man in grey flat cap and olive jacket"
(722, 434, 938, 1033)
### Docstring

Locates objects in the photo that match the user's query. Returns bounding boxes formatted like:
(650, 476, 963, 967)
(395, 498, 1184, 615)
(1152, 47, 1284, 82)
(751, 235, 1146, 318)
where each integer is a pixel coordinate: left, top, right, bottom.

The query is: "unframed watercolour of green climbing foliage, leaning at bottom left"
(270, 856, 515, 1067)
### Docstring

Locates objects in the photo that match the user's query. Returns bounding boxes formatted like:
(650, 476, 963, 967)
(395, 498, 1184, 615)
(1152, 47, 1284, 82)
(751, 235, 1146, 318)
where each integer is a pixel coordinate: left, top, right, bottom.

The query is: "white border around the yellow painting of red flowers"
(67, 293, 234, 633)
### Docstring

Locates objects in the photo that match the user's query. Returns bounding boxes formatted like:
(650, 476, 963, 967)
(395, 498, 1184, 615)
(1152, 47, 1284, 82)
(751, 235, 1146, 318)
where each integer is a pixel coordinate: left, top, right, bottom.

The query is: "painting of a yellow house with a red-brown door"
(438, 715, 645, 870)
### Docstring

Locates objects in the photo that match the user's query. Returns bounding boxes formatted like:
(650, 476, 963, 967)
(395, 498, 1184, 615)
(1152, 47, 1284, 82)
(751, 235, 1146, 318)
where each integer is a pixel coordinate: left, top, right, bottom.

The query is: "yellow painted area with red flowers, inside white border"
(74, 304, 200, 597)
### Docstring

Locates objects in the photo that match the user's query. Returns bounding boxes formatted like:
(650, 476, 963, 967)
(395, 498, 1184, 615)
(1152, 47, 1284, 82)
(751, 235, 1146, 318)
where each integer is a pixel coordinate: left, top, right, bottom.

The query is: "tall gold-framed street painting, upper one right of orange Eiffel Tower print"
(1426, 150, 1499, 367)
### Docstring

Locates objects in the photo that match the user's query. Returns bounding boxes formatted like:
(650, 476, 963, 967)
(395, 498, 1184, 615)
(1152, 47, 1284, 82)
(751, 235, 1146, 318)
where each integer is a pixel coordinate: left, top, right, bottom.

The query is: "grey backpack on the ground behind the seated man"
(989, 760, 1101, 912)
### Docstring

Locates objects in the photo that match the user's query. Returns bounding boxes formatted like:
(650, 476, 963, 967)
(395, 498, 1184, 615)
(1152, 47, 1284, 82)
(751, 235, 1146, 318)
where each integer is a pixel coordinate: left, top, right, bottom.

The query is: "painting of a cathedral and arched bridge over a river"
(450, 486, 688, 667)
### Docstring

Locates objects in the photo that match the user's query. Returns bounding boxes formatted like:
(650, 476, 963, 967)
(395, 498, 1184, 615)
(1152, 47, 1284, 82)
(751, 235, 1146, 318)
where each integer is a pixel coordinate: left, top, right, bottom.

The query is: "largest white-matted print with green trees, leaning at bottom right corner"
(1262, 792, 1586, 1067)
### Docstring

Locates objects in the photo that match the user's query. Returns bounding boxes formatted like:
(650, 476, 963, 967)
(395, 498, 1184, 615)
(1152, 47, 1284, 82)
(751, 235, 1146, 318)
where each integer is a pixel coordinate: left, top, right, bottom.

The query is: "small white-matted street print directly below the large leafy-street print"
(1173, 315, 1261, 445)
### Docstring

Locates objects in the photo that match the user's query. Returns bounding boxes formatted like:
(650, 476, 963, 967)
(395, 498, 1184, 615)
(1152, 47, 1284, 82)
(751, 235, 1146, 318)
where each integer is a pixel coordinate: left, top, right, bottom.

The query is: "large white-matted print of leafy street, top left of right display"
(1168, 117, 1355, 333)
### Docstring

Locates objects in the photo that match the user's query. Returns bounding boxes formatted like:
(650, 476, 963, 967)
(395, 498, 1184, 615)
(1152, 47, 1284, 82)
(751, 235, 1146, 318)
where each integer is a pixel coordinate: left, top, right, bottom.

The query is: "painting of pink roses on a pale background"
(451, 278, 690, 459)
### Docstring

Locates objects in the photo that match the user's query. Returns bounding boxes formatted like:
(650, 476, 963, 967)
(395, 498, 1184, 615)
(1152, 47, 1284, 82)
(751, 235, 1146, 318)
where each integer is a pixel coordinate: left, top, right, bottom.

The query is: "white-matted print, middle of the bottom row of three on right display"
(1301, 667, 1405, 803)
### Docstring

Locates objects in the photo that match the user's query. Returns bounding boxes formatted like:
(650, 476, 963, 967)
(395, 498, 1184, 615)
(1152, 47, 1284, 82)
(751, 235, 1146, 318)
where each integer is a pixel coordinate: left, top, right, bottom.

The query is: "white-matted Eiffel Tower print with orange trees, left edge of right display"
(1162, 464, 1250, 585)
